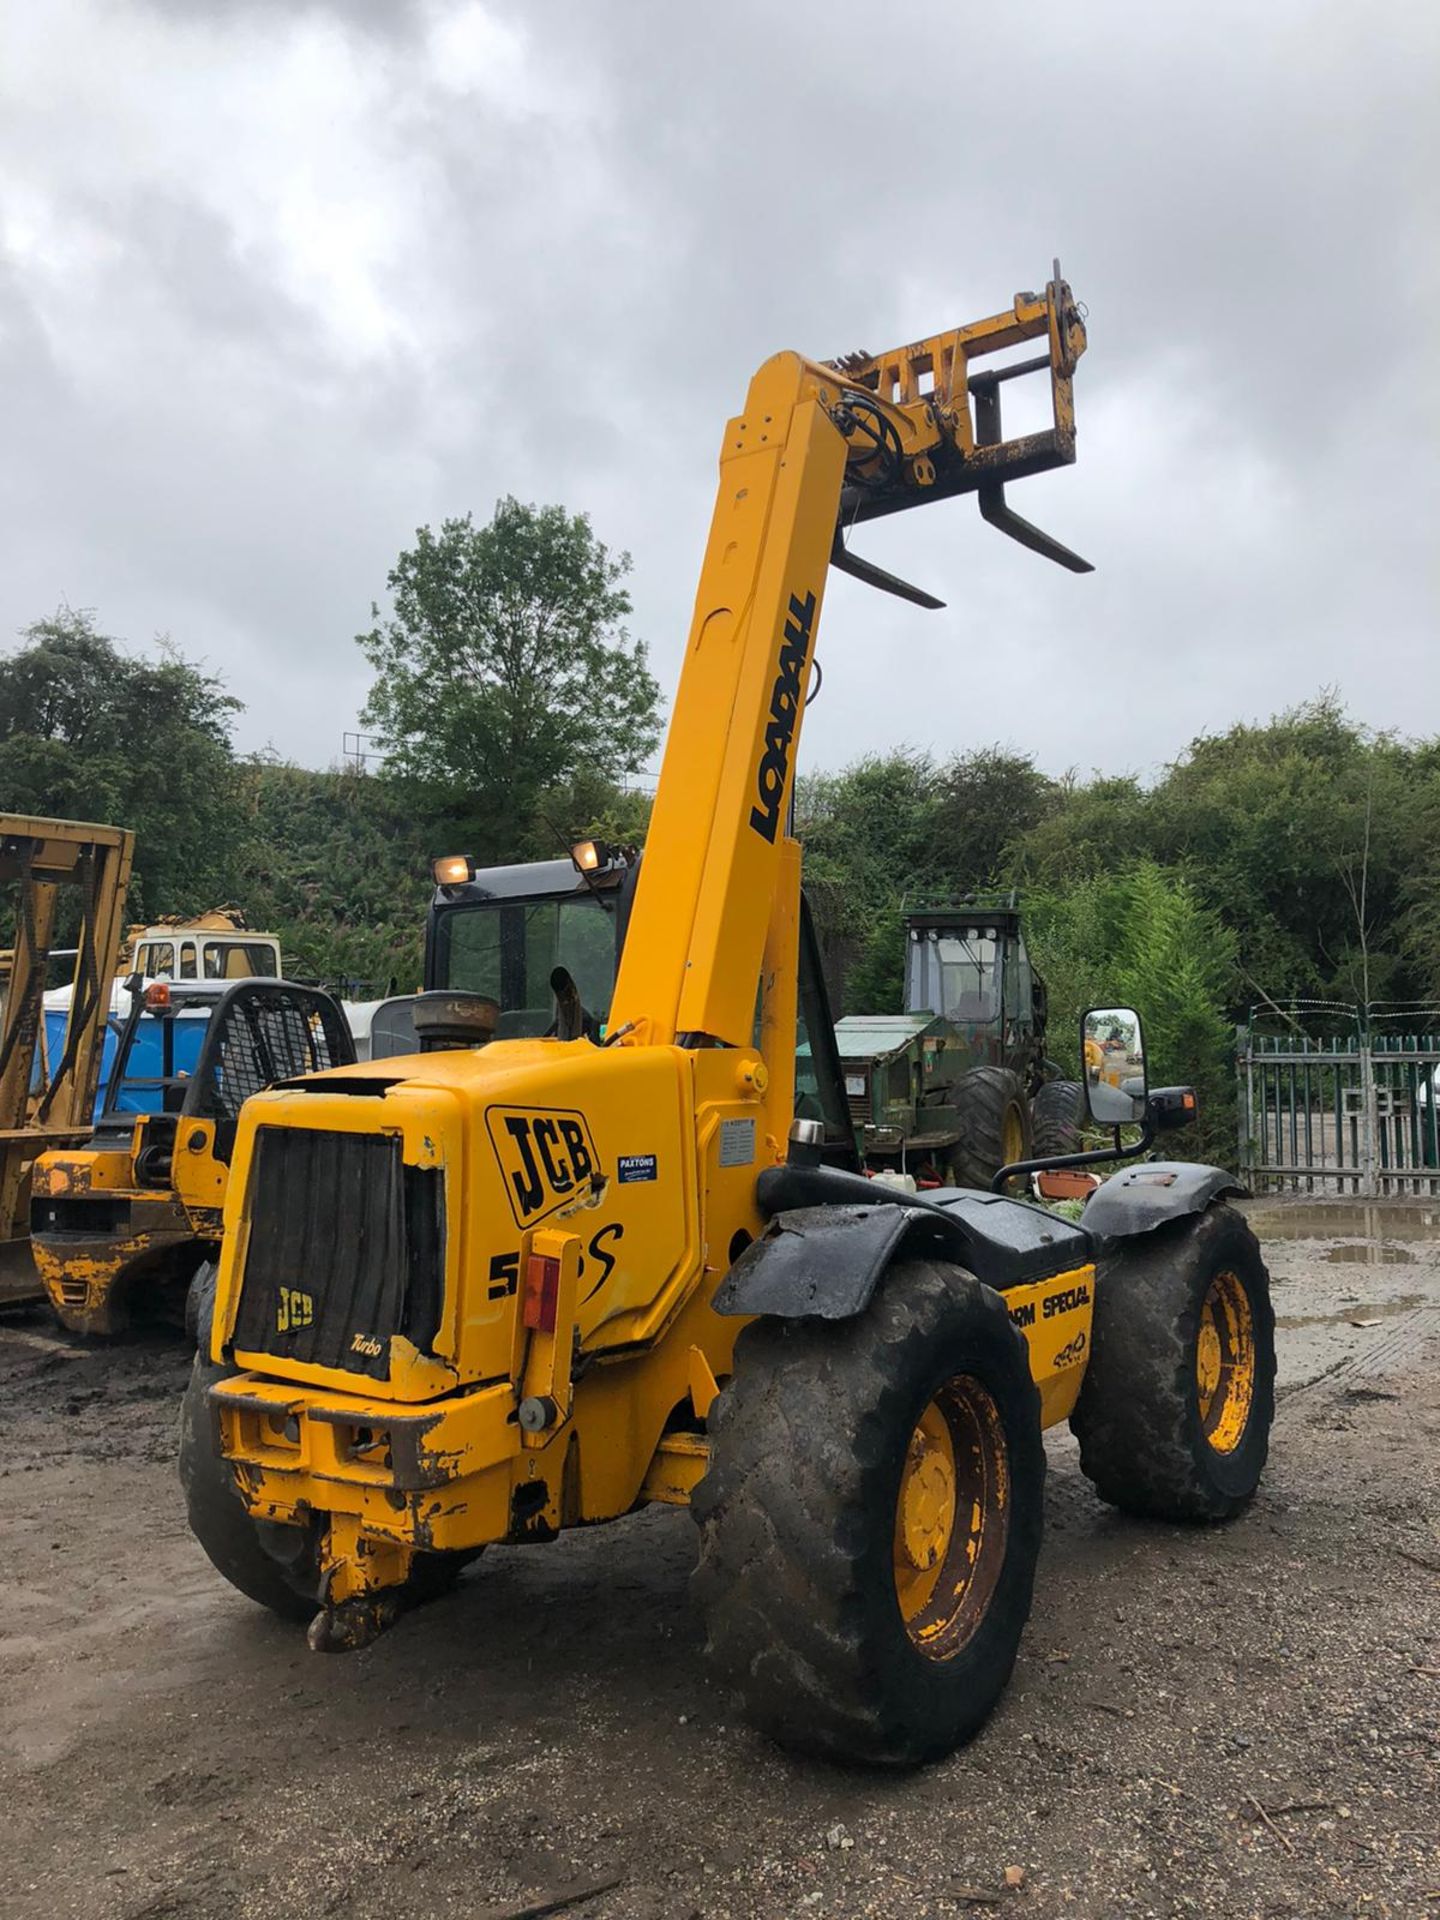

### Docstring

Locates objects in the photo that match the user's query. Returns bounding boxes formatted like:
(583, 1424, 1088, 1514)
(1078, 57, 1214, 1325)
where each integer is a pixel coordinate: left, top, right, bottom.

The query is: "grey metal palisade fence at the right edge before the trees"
(1236, 1002, 1440, 1198)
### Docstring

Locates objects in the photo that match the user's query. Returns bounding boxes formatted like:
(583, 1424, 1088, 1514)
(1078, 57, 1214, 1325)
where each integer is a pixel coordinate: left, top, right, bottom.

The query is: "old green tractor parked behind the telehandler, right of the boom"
(835, 893, 1085, 1187)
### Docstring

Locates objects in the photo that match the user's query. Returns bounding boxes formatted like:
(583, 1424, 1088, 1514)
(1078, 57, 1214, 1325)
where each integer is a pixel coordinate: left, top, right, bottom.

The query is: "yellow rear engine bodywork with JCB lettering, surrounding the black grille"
(211, 1041, 774, 1548)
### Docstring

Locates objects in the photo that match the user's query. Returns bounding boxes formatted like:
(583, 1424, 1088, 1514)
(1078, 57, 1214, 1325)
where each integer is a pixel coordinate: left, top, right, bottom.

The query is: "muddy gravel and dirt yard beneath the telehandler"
(0, 1213, 1440, 1920)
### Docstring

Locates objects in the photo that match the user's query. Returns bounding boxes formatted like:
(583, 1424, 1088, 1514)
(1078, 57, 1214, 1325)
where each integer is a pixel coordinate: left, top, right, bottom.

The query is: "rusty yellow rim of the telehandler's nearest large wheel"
(895, 1375, 1010, 1661)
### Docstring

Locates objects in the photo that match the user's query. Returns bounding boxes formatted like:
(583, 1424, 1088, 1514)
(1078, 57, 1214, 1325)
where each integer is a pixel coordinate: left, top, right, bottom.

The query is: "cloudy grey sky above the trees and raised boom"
(0, 0, 1440, 774)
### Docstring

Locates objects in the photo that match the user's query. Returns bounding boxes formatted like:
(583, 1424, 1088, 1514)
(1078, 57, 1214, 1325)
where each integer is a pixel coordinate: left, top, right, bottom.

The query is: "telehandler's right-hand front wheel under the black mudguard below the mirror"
(1071, 1206, 1275, 1521)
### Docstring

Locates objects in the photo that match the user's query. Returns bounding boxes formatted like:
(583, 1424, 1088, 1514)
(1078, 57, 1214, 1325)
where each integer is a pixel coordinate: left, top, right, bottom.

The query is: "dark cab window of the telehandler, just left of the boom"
(434, 893, 616, 1041)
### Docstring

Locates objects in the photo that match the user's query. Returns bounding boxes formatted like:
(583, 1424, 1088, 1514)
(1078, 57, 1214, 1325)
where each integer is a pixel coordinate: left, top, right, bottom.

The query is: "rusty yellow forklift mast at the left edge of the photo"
(0, 814, 134, 1306)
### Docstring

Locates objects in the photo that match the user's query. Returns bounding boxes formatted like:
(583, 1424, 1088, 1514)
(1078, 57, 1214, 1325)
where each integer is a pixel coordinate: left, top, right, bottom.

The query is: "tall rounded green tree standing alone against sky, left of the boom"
(357, 497, 660, 860)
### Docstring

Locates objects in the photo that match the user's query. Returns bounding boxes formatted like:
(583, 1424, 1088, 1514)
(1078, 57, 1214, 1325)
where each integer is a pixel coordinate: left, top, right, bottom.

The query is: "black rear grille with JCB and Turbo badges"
(234, 1127, 444, 1379)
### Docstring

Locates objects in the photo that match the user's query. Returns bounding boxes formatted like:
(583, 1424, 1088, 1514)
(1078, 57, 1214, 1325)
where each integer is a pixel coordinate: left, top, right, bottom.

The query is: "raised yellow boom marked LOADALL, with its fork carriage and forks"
(611, 265, 1089, 1046)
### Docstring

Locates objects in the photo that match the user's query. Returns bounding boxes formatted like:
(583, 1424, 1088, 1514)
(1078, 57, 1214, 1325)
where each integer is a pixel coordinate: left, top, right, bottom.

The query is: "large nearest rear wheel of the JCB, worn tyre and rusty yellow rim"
(691, 1260, 1044, 1766)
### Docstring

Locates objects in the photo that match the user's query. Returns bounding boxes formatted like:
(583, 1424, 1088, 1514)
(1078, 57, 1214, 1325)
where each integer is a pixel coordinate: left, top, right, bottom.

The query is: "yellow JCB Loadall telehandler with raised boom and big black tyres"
(180, 269, 1273, 1764)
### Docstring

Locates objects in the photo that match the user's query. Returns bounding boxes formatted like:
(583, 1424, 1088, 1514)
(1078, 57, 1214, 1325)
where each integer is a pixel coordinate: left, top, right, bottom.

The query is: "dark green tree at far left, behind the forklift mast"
(0, 607, 240, 918)
